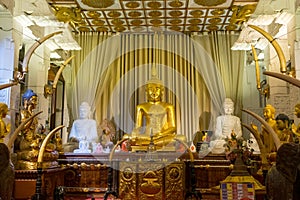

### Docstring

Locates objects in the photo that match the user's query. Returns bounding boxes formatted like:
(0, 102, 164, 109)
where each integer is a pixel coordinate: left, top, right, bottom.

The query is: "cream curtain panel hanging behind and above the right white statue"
(192, 32, 246, 117)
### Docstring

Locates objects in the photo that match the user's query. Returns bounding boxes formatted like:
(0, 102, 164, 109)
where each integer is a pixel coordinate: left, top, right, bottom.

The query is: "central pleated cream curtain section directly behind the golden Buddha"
(96, 34, 210, 140)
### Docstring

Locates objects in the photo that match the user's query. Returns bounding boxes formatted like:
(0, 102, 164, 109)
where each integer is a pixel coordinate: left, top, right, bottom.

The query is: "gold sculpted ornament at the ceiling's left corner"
(54, 7, 82, 23)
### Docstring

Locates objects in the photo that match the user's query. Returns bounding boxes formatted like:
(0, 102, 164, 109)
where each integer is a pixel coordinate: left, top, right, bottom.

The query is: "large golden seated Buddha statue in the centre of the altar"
(129, 71, 185, 150)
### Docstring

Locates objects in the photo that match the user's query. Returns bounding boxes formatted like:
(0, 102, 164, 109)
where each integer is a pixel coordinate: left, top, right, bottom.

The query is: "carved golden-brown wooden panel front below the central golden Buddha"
(119, 162, 185, 200)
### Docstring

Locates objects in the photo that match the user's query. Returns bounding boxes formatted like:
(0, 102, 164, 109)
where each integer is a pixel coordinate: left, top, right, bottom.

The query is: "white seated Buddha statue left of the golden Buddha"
(69, 102, 99, 153)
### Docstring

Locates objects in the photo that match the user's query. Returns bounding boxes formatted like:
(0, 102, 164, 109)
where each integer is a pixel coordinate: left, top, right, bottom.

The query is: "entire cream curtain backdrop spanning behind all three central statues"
(69, 33, 243, 141)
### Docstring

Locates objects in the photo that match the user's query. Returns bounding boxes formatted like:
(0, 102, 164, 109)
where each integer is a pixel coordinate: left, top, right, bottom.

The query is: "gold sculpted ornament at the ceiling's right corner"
(230, 4, 256, 24)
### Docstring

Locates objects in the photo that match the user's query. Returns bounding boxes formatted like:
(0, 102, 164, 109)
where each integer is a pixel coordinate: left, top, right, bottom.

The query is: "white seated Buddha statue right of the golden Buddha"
(210, 98, 242, 154)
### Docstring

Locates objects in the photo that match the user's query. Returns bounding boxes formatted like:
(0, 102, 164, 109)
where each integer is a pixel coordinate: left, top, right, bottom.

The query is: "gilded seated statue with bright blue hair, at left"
(16, 89, 58, 169)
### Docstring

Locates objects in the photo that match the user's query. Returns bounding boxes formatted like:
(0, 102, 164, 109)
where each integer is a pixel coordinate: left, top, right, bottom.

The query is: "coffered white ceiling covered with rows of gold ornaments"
(47, 0, 259, 32)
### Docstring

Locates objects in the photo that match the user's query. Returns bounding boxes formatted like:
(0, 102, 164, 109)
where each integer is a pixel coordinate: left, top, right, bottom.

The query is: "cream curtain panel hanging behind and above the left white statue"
(68, 33, 119, 120)
